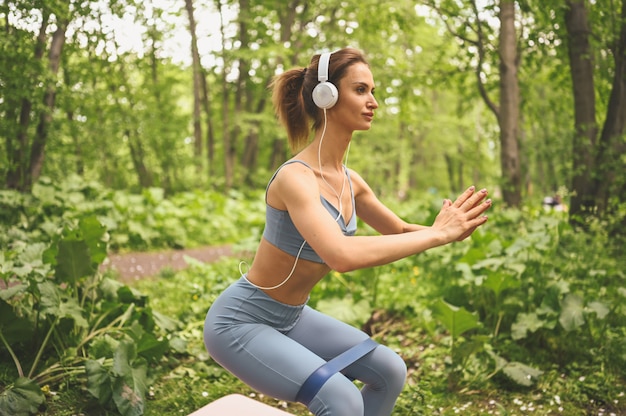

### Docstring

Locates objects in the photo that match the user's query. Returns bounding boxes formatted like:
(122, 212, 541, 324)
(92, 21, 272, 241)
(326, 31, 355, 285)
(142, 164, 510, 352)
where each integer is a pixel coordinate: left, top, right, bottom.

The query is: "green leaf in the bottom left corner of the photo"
(0, 377, 45, 416)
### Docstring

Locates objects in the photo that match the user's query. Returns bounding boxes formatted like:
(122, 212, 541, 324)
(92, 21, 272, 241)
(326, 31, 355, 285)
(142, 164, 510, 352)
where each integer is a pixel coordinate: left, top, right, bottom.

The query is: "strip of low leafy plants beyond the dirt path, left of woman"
(0, 176, 264, 255)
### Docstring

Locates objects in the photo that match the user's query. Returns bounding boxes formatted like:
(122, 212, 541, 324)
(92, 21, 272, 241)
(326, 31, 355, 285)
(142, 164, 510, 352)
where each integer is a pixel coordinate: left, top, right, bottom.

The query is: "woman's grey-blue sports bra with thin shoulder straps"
(263, 159, 356, 263)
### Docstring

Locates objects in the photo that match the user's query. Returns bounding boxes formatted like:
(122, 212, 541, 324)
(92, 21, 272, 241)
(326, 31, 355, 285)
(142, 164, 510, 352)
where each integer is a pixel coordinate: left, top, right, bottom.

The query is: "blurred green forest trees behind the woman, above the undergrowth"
(0, 0, 626, 215)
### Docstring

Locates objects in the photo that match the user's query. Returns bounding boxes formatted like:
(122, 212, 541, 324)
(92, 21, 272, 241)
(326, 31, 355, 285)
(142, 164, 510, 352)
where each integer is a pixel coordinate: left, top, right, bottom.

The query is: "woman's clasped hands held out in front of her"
(432, 186, 492, 242)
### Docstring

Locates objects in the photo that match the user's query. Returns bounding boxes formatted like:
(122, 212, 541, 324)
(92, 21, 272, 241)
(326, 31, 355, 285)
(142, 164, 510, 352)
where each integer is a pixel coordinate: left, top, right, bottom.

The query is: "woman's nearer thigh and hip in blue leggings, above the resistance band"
(204, 281, 324, 401)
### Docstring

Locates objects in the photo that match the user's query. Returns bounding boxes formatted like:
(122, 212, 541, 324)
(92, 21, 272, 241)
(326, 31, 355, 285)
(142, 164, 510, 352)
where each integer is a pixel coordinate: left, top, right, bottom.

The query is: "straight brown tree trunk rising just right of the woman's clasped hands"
(498, 0, 522, 207)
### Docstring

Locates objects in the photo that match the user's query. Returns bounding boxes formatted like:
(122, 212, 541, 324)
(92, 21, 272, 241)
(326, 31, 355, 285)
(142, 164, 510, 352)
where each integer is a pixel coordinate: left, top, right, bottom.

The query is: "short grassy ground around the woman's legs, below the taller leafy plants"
(119, 254, 626, 415)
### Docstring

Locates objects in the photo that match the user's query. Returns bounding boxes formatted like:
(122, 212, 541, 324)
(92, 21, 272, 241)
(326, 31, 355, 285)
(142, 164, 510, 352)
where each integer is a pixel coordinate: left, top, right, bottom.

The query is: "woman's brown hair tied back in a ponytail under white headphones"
(270, 48, 368, 153)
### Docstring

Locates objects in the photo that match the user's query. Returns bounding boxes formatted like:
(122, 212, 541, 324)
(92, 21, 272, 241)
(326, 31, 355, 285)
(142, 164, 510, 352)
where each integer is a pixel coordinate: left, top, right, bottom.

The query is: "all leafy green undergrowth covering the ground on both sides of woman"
(0, 179, 626, 415)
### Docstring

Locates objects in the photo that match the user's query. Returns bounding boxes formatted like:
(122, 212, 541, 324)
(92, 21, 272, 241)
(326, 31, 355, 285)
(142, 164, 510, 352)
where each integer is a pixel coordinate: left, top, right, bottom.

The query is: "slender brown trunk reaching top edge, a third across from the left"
(185, 0, 202, 171)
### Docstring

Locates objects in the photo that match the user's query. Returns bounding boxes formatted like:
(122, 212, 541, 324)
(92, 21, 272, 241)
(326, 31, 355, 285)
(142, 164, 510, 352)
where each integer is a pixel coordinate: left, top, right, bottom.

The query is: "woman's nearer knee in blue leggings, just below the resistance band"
(309, 373, 365, 416)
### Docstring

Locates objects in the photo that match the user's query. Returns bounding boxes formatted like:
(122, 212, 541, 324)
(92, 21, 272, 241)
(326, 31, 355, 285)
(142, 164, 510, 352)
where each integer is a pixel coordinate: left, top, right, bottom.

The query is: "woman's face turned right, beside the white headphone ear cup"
(328, 62, 378, 131)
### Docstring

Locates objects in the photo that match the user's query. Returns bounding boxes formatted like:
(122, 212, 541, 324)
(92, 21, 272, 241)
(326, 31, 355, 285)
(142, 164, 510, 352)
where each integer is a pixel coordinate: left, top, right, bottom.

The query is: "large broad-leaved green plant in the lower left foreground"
(0, 216, 175, 416)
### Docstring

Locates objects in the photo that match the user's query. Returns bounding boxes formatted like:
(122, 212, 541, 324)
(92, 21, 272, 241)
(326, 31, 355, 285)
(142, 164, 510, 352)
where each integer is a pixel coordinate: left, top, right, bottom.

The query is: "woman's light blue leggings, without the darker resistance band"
(204, 278, 406, 416)
